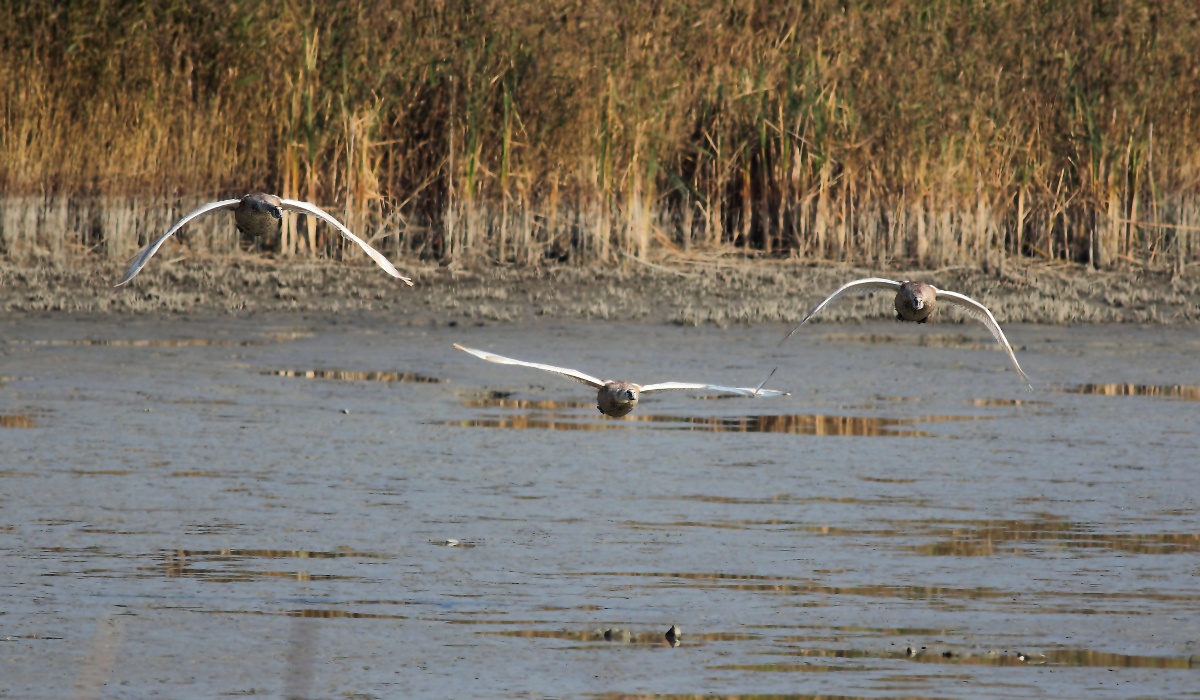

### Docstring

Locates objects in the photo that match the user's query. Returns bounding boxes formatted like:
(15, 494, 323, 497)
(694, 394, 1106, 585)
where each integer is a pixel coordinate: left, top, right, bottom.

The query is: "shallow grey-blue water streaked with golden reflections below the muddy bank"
(0, 315, 1200, 698)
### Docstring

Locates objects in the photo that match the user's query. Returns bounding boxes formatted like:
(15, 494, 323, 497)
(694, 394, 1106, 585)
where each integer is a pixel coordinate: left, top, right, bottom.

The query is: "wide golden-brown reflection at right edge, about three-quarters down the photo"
(908, 519, 1200, 557)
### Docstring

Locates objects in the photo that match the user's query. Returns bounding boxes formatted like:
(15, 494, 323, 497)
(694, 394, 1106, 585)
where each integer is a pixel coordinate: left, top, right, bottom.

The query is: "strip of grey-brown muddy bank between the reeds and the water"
(0, 257, 1200, 327)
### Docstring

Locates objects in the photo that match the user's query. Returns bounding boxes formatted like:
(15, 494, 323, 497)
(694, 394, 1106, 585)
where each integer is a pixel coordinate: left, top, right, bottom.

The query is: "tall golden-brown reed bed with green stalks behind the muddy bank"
(0, 0, 1200, 271)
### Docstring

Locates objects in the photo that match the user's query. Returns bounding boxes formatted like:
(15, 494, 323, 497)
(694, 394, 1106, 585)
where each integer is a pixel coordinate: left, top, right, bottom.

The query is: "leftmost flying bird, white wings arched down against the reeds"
(115, 192, 413, 287)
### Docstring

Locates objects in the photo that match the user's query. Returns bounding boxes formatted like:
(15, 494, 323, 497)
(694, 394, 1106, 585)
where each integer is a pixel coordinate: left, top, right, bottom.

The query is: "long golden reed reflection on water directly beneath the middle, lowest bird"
(446, 408, 989, 437)
